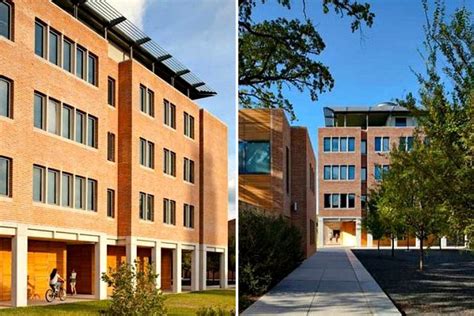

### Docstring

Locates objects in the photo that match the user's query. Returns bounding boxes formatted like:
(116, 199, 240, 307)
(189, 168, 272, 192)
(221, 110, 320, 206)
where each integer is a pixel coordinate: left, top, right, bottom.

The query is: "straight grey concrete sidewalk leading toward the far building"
(243, 248, 400, 316)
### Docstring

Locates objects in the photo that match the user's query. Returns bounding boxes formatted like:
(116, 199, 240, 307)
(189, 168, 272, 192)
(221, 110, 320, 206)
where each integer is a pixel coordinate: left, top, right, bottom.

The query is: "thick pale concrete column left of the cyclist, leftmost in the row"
(11, 225, 28, 307)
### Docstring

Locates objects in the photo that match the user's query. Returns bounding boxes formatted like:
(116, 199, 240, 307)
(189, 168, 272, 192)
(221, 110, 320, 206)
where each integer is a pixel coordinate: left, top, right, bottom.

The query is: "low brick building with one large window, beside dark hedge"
(239, 109, 316, 257)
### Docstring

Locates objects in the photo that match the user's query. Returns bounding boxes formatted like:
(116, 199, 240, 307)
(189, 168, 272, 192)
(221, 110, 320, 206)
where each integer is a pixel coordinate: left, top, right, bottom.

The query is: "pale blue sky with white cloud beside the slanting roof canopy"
(107, 0, 236, 218)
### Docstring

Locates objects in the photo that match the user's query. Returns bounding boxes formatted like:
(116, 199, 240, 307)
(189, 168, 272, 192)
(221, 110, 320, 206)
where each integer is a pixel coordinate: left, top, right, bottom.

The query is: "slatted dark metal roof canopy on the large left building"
(54, 0, 217, 99)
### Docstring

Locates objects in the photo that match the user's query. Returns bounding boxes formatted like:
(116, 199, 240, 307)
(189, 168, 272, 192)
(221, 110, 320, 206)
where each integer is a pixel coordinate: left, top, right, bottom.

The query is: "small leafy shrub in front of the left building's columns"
(102, 263, 166, 316)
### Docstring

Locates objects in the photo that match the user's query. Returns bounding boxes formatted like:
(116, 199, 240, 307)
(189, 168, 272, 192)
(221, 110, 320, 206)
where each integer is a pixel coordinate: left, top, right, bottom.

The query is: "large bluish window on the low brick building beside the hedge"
(239, 141, 271, 174)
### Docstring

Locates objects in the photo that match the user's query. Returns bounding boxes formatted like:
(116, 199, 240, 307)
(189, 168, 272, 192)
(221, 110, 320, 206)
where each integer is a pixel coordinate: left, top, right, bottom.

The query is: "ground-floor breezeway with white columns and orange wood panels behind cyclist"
(0, 223, 228, 306)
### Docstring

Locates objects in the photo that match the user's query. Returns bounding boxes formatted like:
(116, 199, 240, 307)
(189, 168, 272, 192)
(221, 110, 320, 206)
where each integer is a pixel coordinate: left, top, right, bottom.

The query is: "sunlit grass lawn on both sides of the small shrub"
(0, 290, 235, 316)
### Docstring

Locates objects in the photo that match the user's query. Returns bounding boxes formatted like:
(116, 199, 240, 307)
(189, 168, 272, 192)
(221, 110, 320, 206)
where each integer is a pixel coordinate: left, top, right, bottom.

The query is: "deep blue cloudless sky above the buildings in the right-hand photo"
(250, 0, 468, 151)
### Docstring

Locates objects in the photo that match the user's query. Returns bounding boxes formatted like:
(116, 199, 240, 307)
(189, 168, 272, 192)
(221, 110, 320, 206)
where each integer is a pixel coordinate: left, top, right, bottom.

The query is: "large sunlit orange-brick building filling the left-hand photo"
(0, 0, 228, 306)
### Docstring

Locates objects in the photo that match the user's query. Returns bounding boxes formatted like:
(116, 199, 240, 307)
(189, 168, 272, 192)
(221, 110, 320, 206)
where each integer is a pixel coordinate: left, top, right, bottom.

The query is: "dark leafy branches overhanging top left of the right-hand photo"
(239, 0, 375, 120)
